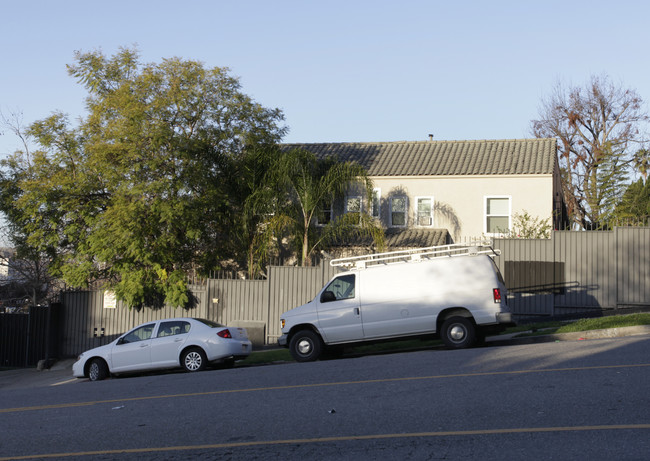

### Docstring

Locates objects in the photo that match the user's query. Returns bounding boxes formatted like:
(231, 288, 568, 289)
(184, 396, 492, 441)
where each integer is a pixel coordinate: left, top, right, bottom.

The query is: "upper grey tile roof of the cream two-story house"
(282, 138, 556, 177)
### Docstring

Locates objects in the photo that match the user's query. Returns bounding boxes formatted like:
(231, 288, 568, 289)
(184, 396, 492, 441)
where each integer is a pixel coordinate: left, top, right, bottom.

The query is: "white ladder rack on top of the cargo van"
(330, 241, 501, 269)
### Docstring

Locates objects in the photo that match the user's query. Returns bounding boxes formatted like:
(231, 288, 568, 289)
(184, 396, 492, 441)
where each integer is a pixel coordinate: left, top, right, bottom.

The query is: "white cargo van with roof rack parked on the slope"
(278, 243, 514, 362)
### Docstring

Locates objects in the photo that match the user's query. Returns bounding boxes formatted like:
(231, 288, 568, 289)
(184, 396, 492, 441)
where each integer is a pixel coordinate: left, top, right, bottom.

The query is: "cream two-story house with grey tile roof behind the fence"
(284, 138, 565, 249)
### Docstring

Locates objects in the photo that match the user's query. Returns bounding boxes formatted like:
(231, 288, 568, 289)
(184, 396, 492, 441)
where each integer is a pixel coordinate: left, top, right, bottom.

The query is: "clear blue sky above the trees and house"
(0, 0, 650, 156)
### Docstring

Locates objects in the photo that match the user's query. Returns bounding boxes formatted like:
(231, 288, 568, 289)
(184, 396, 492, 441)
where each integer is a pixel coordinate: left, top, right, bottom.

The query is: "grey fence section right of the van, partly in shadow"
(495, 227, 650, 316)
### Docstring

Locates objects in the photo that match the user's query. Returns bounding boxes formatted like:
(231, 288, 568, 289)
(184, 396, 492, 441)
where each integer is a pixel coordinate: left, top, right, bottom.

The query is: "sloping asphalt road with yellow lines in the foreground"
(0, 335, 650, 460)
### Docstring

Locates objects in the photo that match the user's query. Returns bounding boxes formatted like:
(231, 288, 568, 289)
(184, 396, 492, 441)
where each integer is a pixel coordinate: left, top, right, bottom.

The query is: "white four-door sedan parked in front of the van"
(72, 318, 252, 381)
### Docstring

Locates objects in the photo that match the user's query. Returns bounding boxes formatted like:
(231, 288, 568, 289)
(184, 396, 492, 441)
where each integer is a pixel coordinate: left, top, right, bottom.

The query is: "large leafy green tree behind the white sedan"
(2, 49, 284, 307)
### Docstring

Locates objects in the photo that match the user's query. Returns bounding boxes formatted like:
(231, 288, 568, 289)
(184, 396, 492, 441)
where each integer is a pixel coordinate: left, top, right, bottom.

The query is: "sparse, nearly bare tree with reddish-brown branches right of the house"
(532, 76, 648, 229)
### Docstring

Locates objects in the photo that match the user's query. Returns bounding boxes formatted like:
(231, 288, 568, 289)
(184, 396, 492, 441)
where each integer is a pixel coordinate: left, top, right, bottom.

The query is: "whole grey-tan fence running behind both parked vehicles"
(60, 227, 650, 356)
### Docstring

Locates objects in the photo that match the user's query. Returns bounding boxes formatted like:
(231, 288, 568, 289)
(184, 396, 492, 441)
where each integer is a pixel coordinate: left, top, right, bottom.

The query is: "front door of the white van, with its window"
(315, 274, 363, 343)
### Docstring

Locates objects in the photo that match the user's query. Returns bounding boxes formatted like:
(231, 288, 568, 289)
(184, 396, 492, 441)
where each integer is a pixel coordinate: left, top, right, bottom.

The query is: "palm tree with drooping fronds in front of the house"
(248, 149, 384, 266)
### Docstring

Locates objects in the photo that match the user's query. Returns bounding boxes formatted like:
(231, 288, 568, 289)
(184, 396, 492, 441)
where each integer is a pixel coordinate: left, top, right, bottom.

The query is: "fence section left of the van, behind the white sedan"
(62, 264, 337, 356)
